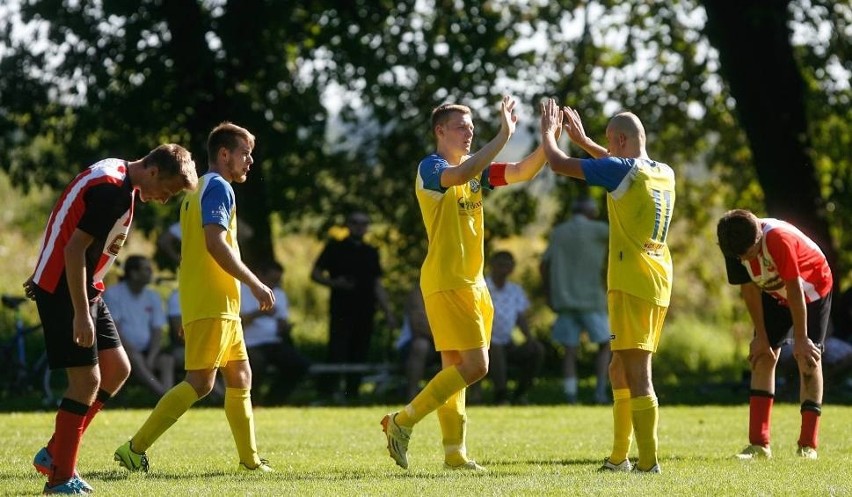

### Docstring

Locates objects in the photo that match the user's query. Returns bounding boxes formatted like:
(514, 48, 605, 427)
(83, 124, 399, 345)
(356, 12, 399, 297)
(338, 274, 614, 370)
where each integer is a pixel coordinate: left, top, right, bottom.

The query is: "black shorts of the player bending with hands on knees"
(761, 292, 831, 349)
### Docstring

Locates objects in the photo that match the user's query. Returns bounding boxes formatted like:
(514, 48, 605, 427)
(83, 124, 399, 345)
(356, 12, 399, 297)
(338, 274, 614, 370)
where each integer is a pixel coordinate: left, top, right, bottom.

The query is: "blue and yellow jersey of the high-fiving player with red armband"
(415, 153, 505, 296)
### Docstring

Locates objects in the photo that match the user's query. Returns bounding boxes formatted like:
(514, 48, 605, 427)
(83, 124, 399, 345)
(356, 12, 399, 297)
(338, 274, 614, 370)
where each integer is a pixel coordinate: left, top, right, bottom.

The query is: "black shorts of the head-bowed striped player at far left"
(33, 285, 121, 369)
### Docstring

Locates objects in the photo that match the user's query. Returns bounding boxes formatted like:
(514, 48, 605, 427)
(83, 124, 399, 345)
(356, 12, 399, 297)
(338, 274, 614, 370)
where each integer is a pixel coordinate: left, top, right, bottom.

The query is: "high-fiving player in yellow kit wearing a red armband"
(382, 96, 545, 470)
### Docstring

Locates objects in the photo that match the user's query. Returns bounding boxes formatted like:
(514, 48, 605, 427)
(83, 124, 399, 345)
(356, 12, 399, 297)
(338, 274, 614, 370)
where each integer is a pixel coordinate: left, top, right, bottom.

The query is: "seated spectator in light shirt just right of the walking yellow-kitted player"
(240, 261, 311, 405)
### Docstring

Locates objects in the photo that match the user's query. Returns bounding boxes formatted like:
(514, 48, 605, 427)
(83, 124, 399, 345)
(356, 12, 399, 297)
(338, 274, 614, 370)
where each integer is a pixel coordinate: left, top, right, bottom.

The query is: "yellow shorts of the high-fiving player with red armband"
(423, 286, 494, 351)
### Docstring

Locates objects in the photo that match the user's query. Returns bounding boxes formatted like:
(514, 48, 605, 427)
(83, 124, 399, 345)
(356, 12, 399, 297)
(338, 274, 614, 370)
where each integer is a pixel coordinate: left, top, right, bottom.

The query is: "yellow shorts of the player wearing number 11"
(607, 290, 668, 352)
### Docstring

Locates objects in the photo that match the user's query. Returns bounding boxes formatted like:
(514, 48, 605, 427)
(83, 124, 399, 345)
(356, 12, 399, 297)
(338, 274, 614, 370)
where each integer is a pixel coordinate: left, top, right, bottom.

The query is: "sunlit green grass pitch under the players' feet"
(0, 404, 852, 497)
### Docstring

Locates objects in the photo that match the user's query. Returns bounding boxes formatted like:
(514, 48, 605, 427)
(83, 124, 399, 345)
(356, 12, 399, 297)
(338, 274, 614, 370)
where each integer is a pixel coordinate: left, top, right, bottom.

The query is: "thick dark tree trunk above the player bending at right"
(703, 0, 837, 268)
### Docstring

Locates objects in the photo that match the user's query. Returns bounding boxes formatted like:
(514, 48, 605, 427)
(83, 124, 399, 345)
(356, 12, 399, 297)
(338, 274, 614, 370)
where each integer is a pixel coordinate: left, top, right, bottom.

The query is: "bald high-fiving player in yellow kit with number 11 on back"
(541, 99, 675, 473)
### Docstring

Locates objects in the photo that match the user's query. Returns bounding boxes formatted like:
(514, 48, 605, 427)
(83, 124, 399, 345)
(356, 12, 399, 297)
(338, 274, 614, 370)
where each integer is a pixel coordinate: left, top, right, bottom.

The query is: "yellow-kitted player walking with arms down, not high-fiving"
(115, 122, 275, 472)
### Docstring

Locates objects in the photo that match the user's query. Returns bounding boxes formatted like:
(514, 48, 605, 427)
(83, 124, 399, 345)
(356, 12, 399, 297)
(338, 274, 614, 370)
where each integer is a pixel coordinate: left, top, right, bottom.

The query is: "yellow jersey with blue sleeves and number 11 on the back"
(582, 157, 675, 306)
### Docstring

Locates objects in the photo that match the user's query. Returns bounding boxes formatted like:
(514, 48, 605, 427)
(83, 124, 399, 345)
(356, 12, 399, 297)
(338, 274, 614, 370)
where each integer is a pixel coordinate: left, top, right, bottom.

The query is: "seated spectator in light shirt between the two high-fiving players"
(472, 251, 544, 405)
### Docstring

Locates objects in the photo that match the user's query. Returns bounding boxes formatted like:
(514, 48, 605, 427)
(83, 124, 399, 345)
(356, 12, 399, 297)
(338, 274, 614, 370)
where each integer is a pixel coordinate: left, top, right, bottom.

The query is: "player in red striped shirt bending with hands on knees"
(716, 209, 833, 460)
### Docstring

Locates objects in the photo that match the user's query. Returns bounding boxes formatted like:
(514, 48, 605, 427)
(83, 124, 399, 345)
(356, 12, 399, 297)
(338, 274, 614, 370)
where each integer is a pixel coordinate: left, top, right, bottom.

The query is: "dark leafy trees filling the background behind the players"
(0, 0, 852, 310)
